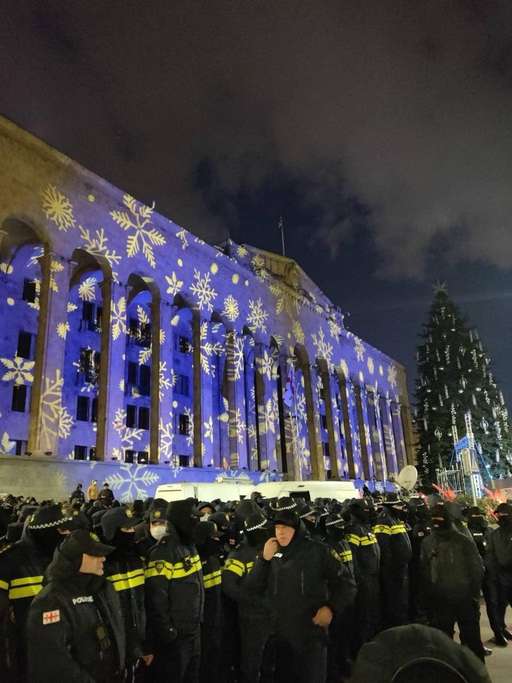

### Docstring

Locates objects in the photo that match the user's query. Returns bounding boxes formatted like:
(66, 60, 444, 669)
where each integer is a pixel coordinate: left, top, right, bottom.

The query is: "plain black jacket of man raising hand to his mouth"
(247, 526, 356, 647)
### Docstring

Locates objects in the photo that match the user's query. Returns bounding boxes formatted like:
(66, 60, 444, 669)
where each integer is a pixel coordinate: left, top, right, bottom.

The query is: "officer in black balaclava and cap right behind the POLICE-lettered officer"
(101, 507, 153, 683)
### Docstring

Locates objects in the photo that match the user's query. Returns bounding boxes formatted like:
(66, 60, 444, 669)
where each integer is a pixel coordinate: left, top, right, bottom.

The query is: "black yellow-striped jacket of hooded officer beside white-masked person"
(146, 523, 204, 647)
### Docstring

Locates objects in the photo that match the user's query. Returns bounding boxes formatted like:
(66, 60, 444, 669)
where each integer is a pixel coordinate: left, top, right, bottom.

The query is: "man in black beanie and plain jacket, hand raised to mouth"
(247, 498, 355, 683)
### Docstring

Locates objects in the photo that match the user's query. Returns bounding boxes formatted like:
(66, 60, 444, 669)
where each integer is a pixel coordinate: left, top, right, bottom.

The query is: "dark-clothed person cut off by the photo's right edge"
(487, 503, 512, 646)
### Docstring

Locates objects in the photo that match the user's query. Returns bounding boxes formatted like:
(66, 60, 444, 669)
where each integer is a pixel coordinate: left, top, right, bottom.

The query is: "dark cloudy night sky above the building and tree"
(0, 0, 512, 406)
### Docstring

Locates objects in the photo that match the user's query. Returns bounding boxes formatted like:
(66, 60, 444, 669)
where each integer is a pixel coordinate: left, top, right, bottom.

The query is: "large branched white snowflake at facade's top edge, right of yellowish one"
(110, 194, 166, 268)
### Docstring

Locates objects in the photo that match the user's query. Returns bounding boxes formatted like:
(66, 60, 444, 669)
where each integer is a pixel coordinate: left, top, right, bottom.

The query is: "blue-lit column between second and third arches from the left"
(96, 276, 128, 461)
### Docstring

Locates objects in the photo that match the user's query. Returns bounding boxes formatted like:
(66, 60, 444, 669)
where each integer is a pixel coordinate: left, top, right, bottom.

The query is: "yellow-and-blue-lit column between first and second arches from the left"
(28, 246, 74, 457)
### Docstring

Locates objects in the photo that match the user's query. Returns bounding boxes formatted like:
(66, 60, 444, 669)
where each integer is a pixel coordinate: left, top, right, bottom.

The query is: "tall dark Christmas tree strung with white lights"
(416, 285, 512, 483)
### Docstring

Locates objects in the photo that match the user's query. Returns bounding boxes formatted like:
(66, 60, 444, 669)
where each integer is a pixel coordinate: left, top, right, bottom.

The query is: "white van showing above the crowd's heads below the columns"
(155, 480, 361, 502)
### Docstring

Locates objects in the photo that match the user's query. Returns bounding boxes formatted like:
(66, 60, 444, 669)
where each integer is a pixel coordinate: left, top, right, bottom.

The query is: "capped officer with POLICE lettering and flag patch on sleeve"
(27, 529, 125, 683)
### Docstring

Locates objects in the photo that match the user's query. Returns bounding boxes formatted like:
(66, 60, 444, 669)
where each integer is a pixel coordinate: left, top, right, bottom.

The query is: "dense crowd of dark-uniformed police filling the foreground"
(0, 482, 512, 683)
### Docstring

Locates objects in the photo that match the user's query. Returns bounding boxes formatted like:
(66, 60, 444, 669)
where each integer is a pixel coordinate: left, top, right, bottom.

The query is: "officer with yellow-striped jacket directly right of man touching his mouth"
(346, 497, 381, 654)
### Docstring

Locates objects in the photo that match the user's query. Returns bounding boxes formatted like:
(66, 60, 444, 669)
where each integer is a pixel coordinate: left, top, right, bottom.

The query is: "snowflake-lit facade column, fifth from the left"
(226, 330, 248, 469)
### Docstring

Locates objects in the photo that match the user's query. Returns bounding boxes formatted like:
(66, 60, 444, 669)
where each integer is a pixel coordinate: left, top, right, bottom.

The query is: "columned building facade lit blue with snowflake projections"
(0, 115, 411, 480)
